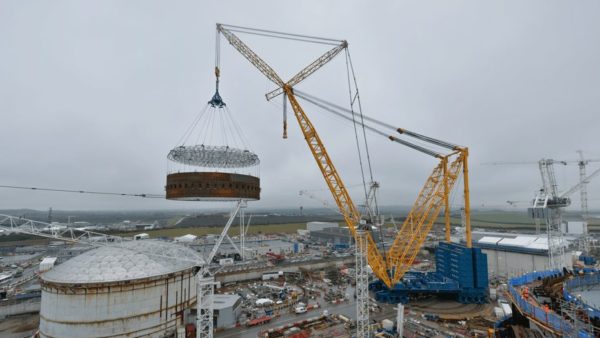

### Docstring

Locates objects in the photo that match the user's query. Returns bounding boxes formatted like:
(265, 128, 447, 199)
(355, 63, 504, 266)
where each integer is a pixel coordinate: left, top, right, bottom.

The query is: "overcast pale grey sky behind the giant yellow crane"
(0, 0, 600, 209)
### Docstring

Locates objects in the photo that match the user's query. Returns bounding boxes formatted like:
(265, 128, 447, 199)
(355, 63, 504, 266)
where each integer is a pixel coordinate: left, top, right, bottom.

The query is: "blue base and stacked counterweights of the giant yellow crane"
(369, 242, 488, 304)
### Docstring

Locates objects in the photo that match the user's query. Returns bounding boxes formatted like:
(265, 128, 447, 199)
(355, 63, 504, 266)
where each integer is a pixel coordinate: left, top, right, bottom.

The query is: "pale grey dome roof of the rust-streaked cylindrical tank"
(41, 240, 204, 284)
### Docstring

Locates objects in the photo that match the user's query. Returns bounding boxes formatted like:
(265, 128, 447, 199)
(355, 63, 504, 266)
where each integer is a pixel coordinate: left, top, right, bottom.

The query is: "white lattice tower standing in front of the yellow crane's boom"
(355, 229, 370, 338)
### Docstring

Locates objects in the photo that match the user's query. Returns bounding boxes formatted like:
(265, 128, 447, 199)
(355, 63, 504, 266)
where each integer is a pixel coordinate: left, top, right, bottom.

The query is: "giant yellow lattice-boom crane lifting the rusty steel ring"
(215, 24, 471, 287)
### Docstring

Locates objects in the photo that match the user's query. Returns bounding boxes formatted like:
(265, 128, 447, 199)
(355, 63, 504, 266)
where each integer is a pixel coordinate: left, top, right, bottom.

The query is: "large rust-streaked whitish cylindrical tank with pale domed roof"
(40, 240, 202, 338)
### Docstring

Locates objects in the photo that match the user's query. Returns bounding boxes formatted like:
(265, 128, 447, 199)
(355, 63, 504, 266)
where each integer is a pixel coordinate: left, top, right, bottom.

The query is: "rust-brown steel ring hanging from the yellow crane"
(165, 172, 260, 201)
